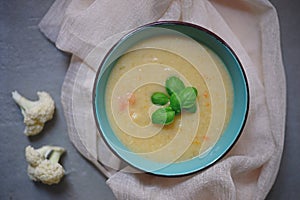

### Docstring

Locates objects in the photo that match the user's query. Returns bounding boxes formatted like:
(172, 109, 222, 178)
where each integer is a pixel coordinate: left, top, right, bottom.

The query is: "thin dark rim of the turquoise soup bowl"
(92, 20, 250, 177)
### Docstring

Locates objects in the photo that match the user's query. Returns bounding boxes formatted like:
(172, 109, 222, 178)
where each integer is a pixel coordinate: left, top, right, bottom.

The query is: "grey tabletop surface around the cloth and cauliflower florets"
(0, 0, 300, 200)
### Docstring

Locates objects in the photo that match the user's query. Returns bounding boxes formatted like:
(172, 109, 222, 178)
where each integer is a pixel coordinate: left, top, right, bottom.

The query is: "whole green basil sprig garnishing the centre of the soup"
(151, 76, 198, 125)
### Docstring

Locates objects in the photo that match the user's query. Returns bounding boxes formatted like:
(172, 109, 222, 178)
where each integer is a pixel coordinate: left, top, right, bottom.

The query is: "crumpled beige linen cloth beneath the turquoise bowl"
(40, 0, 286, 200)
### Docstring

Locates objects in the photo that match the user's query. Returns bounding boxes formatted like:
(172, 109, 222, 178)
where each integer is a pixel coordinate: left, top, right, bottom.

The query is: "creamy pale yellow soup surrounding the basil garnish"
(106, 35, 233, 162)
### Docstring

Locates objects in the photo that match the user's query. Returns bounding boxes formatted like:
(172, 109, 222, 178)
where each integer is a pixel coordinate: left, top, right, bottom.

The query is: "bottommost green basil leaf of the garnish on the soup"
(151, 107, 175, 125)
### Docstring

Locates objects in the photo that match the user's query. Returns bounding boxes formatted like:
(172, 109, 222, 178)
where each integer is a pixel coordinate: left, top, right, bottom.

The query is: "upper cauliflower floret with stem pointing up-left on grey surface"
(12, 91, 55, 136)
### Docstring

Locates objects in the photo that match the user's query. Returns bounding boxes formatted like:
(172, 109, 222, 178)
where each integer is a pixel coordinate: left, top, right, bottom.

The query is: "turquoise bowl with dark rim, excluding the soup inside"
(93, 21, 249, 176)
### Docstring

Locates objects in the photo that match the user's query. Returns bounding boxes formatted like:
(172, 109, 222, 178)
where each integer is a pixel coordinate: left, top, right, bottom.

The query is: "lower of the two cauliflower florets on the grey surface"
(25, 146, 65, 185)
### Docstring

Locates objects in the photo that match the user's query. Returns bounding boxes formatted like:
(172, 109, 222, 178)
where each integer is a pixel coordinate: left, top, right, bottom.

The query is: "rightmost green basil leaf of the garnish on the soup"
(179, 87, 198, 108)
